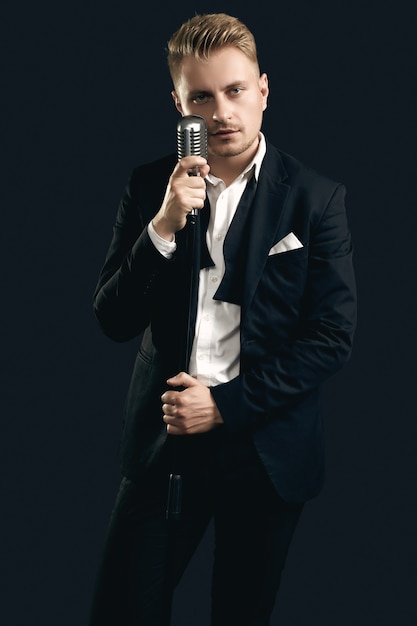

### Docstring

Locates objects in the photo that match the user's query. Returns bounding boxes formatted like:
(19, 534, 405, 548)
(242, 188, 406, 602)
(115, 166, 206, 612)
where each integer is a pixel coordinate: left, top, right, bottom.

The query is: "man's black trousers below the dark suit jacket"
(90, 428, 303, 626)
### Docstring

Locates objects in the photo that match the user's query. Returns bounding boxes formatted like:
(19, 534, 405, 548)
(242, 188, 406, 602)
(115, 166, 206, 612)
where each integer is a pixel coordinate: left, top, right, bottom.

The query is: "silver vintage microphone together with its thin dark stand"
(166, 115, 208, 521)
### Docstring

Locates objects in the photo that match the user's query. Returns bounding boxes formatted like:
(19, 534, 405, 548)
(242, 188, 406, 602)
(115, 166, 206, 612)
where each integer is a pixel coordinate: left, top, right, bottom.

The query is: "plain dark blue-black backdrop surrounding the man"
(0, 0, 417, 626)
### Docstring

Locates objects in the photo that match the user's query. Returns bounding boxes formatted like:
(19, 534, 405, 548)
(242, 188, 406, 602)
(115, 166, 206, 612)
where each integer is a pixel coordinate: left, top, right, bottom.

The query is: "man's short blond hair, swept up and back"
(168, 13, 259, 85)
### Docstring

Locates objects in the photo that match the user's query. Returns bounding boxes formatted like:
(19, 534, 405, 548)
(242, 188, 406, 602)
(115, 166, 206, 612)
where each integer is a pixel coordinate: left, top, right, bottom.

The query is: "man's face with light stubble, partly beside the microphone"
(172, 47, 268, 166)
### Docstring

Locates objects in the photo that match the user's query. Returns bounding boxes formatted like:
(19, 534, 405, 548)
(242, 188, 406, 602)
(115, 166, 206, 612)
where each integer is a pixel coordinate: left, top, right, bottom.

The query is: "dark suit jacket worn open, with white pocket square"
(94, 143, 356, 501)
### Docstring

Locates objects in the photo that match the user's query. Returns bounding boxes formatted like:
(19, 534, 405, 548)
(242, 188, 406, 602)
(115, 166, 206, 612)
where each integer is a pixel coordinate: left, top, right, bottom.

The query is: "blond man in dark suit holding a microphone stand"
(90, 14, 355, 626)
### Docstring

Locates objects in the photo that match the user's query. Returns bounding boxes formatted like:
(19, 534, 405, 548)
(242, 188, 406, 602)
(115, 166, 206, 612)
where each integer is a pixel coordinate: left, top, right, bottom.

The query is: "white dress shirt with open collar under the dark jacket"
(148, 133, 266, 387)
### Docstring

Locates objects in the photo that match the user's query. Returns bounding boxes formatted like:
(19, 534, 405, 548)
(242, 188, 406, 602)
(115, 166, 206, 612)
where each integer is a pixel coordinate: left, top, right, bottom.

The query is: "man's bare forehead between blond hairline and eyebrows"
(177, 47, 259, 91)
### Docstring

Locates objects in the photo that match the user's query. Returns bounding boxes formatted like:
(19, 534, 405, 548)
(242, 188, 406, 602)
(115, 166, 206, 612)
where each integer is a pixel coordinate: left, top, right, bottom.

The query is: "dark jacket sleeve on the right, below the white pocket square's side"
(211, 185, 356, 431)
